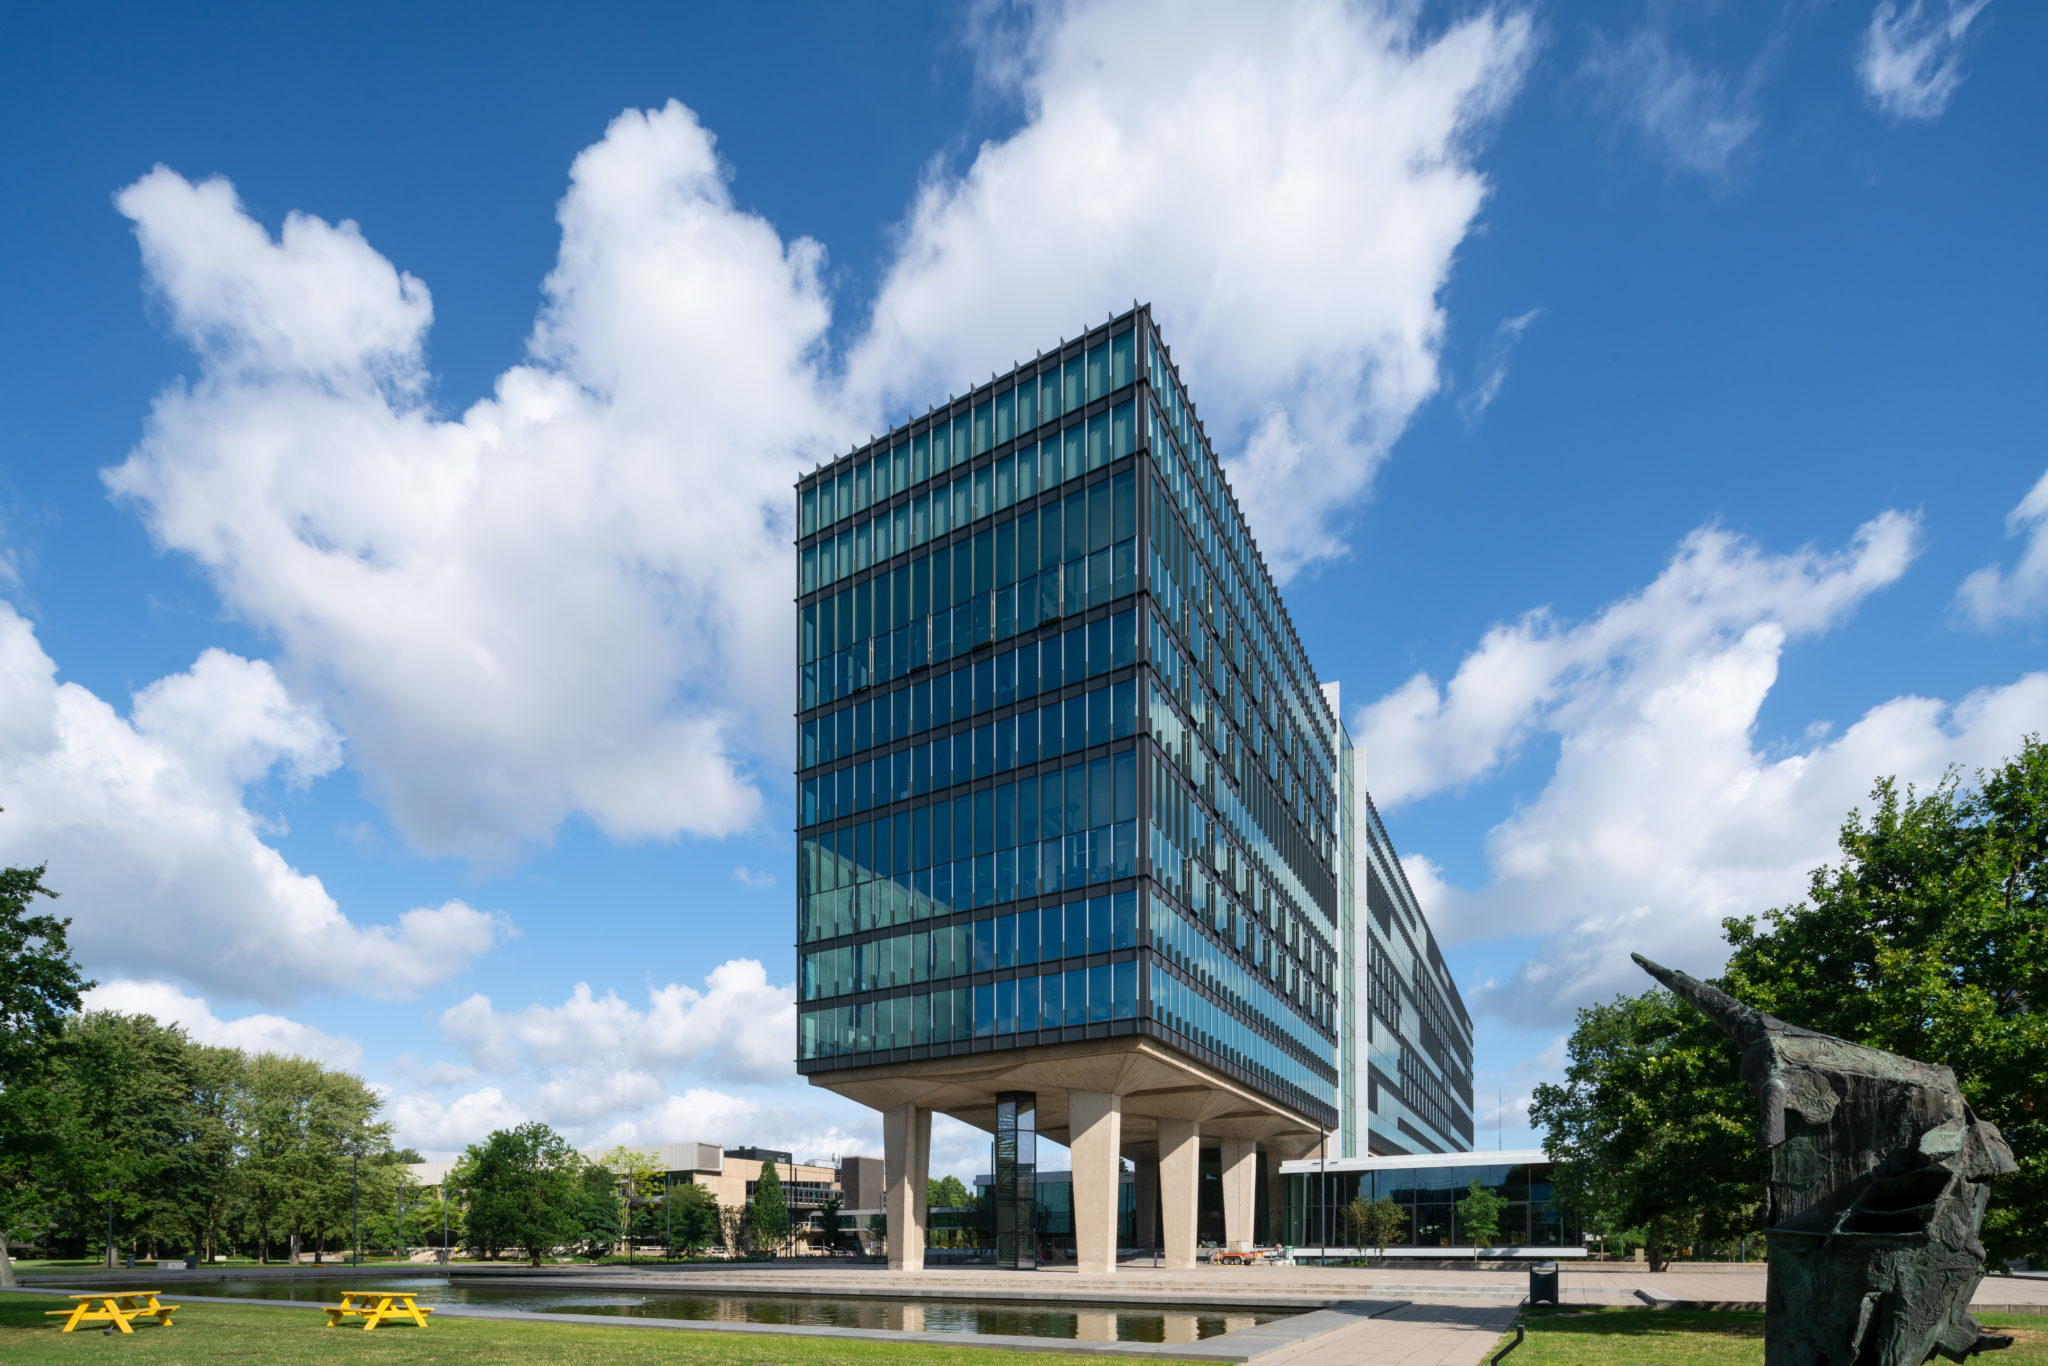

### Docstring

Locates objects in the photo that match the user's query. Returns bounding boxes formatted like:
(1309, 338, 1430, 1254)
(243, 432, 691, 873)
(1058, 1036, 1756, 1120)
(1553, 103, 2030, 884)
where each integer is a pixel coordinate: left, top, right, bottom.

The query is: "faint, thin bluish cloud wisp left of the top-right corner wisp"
(1583, 27, 1763, 184)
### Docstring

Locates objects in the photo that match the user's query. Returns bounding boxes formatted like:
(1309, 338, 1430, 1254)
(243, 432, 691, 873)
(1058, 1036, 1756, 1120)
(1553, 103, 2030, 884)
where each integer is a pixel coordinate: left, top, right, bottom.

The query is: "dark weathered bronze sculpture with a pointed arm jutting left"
(1632, 954, 2015, 1366)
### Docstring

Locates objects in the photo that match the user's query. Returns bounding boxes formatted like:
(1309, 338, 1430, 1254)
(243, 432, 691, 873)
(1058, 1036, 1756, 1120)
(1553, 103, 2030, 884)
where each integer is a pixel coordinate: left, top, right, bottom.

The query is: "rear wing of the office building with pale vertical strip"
(1337, 786, 1473, 1157)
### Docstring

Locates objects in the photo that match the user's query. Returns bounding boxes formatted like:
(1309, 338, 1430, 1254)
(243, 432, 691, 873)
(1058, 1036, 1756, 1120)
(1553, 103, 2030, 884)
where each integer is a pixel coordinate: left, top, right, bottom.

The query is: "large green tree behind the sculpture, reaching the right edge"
(1720, 735, 2048, 1262)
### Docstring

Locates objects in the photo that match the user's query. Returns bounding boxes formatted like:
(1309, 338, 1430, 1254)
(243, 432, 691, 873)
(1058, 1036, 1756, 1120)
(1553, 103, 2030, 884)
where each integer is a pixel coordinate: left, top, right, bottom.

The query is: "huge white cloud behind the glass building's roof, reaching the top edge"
(850, 0, 1532, 575)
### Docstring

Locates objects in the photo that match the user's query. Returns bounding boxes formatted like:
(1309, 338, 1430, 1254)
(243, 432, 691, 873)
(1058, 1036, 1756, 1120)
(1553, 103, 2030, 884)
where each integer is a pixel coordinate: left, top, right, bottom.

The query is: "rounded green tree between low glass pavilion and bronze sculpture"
(1530, 987, 1767, 1272)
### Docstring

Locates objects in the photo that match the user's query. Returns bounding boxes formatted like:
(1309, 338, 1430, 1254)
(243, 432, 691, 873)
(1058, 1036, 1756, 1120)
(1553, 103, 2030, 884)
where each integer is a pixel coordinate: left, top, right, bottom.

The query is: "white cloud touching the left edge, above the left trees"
(0, 604, 506, 1004)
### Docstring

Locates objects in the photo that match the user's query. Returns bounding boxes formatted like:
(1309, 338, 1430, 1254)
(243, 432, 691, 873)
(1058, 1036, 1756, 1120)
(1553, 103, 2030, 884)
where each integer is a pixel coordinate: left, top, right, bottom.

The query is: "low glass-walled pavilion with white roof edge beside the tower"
(1280, 1149, 1585, 1257)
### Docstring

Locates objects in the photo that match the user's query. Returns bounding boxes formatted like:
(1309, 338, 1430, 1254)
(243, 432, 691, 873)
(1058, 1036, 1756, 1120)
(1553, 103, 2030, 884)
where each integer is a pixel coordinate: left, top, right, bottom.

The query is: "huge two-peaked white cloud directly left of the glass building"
(106, 104, 850, 858)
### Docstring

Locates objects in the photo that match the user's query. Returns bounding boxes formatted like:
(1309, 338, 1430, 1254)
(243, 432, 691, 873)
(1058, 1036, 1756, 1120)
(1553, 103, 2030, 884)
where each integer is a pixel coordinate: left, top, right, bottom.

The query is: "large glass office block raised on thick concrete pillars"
(797, 307, 1350, 1270)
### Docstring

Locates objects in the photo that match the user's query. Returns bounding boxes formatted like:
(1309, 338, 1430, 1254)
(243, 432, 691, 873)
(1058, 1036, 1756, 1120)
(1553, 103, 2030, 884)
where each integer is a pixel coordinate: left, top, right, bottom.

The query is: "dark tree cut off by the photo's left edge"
(0, 864, 94, 1286)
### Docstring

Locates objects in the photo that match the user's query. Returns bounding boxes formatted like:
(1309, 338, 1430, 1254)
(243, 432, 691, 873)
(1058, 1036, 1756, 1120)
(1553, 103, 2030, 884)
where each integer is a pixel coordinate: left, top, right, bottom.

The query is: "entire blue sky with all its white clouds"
(0, 0, 2048, 1171)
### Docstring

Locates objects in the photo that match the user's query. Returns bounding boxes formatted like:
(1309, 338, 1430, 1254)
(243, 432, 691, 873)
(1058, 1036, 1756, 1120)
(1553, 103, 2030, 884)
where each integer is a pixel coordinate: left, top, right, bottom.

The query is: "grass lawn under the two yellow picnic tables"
(0, 1294, 1196, 1366)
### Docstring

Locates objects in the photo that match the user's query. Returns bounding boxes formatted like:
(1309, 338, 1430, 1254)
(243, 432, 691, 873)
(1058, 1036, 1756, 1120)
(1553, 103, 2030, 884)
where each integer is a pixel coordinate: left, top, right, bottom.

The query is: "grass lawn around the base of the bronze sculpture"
(1487, 1309, 2048, 1366)
